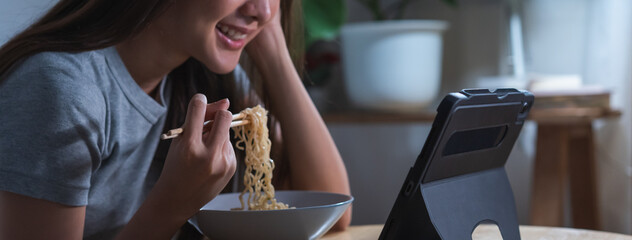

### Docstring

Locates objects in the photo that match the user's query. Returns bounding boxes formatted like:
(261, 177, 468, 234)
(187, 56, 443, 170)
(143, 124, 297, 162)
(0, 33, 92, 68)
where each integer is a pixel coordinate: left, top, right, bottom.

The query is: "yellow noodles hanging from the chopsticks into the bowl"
(233, 105, 288, 210)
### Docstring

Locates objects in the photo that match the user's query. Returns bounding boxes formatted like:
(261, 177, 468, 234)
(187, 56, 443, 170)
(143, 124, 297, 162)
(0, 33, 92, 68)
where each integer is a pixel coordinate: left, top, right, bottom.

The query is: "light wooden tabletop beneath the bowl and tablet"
(321, 224, 632, 240)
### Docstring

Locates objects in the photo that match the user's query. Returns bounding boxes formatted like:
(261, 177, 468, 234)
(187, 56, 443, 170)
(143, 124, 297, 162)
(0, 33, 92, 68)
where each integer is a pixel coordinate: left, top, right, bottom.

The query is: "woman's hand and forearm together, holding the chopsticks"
(118, 94, 236, 239)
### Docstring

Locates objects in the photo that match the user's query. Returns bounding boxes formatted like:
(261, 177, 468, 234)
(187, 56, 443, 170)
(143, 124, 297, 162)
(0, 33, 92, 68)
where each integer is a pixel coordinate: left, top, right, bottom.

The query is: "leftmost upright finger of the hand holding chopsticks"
(183, 93, 207, 139)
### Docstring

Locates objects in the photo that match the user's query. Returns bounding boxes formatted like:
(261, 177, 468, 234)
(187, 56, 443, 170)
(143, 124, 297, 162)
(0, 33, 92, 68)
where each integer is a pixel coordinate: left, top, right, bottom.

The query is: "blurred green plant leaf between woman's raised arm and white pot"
(303, 0, 347, 47)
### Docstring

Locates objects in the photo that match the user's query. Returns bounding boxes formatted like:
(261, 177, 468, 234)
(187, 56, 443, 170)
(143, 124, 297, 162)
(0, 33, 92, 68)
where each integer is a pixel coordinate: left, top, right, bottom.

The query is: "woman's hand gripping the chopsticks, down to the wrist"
(155, 94, 236, 219)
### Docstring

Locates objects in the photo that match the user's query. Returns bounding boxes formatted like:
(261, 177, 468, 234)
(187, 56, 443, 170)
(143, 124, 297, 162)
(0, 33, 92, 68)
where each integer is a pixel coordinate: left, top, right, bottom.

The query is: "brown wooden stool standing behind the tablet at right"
(530, 108, 621, 229)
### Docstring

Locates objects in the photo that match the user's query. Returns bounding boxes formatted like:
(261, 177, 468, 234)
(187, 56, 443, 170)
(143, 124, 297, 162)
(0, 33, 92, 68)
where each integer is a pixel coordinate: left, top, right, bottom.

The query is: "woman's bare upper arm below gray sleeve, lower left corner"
(0, 191, 86, 239)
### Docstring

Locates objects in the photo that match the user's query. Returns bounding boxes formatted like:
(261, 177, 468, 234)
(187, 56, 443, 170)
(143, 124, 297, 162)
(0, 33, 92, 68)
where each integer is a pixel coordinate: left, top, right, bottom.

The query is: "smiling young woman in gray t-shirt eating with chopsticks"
(0, 0, 350, 239)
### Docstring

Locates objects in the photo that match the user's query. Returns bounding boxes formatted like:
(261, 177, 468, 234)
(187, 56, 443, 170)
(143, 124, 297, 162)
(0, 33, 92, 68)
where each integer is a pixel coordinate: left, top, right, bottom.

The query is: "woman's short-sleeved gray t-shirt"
(0, 47, 170, 239)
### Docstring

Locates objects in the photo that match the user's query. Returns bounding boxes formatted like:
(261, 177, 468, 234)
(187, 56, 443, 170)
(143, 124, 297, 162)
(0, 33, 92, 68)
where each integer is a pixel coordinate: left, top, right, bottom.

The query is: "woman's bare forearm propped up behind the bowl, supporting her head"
(247, 11, 351, 230)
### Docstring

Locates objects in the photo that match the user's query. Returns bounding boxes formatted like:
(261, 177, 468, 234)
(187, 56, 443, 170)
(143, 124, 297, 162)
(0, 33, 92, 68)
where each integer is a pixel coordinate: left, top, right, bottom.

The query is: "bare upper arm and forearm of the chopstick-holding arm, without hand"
(0, 185, 198, 240)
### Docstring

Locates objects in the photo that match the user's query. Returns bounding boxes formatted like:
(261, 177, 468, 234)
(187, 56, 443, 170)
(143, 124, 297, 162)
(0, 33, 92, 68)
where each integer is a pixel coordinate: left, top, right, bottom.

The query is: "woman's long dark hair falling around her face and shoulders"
(0, 0, 303, 186)
